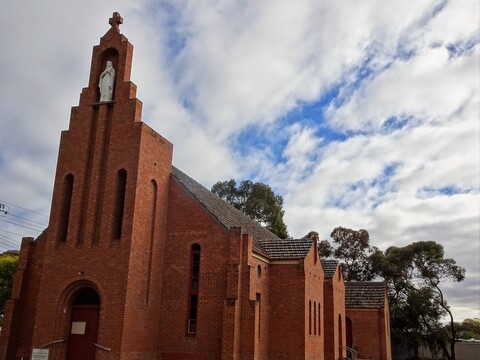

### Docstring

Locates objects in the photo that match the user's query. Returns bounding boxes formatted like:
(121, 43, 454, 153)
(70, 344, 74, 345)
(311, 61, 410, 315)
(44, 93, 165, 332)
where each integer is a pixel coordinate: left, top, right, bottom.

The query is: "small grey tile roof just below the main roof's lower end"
(260, 239, 312, 259)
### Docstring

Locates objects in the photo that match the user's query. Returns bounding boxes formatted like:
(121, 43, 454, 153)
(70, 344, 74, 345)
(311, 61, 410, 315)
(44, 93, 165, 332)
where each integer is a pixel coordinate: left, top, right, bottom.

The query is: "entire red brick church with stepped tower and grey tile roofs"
(0, 13, 391, 360)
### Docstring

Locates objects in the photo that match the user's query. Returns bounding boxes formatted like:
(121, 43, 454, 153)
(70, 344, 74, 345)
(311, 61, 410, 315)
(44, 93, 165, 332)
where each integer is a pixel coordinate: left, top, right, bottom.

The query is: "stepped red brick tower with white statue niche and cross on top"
(0, 13, 173, 360)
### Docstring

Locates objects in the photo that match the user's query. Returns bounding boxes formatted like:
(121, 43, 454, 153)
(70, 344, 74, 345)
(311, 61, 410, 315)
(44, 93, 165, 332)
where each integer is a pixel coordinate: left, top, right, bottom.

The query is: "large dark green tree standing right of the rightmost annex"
(372, 241, 465, 360)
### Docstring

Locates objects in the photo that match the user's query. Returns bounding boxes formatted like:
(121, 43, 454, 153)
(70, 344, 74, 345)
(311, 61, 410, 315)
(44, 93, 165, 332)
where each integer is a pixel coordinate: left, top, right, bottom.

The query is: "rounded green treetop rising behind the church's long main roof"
(211, 179, 289, 239)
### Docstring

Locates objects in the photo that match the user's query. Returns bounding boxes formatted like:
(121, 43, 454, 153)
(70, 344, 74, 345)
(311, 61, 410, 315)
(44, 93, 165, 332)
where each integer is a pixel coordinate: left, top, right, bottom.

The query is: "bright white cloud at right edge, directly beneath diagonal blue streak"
(328, 45, 480, 131)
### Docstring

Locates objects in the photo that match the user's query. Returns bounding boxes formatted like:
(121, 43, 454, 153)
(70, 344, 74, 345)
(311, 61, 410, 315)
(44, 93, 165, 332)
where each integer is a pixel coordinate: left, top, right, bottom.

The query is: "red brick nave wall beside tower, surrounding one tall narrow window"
(159, 180, 232, 357)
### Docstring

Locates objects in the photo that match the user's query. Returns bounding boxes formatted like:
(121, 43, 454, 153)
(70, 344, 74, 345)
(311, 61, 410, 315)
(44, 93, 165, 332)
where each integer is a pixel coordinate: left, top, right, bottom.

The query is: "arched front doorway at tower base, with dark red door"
(67, 287, 100, 360)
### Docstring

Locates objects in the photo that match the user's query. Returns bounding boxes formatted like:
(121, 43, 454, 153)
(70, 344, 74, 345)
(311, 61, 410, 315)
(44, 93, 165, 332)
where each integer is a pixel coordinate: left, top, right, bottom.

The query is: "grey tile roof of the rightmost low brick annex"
(345, 281, 387, 309)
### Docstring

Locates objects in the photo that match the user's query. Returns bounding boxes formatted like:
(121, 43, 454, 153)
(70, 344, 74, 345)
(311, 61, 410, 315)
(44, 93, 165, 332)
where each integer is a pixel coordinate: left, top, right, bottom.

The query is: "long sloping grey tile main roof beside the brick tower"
(172, 166, 279, 256)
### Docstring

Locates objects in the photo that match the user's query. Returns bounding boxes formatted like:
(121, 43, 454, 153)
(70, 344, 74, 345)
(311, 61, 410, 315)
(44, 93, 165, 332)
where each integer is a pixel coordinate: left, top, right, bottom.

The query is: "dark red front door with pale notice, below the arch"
(67, 305, 100, 360)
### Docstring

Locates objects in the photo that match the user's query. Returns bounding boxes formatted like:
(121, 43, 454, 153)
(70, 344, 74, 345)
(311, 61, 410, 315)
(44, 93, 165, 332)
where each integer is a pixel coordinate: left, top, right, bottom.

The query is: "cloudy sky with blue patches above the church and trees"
(0, 0, 480, 319)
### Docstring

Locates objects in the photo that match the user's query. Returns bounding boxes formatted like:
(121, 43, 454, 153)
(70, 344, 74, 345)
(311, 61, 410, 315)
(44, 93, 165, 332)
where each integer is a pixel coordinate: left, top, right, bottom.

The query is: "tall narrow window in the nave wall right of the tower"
(187, 244, 200, 336)
